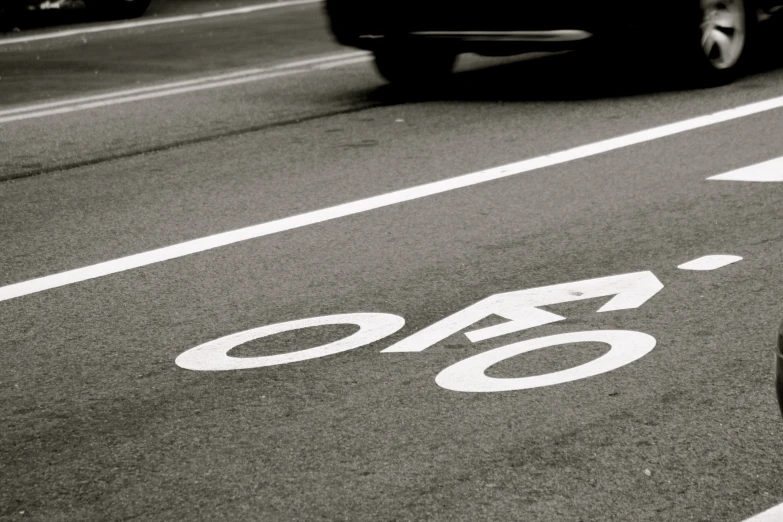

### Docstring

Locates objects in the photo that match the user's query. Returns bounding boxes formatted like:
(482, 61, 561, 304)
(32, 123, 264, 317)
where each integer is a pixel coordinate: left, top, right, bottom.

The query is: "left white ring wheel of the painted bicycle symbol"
(174, 313, 405, 371)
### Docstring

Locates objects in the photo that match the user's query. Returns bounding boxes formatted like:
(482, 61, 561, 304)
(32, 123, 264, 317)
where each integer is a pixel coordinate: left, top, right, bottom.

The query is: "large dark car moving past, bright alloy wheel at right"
(325, 0, 783, 84)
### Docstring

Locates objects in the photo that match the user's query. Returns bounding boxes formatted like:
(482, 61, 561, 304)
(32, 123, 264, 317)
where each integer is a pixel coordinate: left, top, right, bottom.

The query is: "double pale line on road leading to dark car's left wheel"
(0, 51, 370, 123)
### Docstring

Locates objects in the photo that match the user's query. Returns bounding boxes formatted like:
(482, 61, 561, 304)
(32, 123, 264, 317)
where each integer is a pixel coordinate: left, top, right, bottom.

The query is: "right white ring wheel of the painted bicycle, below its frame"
(435, 330, 655, 393)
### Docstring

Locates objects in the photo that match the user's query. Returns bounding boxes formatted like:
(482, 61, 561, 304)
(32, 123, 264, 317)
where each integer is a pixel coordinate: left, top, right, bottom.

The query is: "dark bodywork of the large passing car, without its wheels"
(326, 0, 660, 54)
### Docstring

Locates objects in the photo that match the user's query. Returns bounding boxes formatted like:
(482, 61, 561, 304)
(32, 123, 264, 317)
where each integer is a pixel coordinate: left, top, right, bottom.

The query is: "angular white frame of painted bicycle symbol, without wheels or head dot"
(383, 272, 663, 352)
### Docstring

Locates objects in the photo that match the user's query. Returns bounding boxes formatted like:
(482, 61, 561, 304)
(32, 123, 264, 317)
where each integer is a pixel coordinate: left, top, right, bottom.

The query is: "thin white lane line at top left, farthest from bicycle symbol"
(0, 0, 321, 46)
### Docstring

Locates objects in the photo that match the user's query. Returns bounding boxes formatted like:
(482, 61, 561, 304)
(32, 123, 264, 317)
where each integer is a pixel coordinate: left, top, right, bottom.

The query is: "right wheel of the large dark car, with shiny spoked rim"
(671, 0, 757, 86)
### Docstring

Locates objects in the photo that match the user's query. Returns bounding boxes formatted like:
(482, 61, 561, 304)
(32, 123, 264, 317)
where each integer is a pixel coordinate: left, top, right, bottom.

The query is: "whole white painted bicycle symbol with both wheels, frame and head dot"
(175, 256, 741, 392)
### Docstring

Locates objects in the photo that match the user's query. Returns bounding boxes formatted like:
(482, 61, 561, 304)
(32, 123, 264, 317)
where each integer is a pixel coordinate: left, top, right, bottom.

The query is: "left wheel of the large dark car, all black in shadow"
(373, 46, 457, 89)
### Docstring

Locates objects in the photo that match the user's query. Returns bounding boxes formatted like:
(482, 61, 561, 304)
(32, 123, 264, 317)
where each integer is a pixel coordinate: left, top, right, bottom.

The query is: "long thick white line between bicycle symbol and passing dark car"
(0, 96, 783, 301)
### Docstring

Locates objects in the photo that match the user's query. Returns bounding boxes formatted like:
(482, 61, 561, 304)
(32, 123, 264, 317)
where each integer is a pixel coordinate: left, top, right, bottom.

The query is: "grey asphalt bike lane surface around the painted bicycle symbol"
(0, 102, 783, 520)
